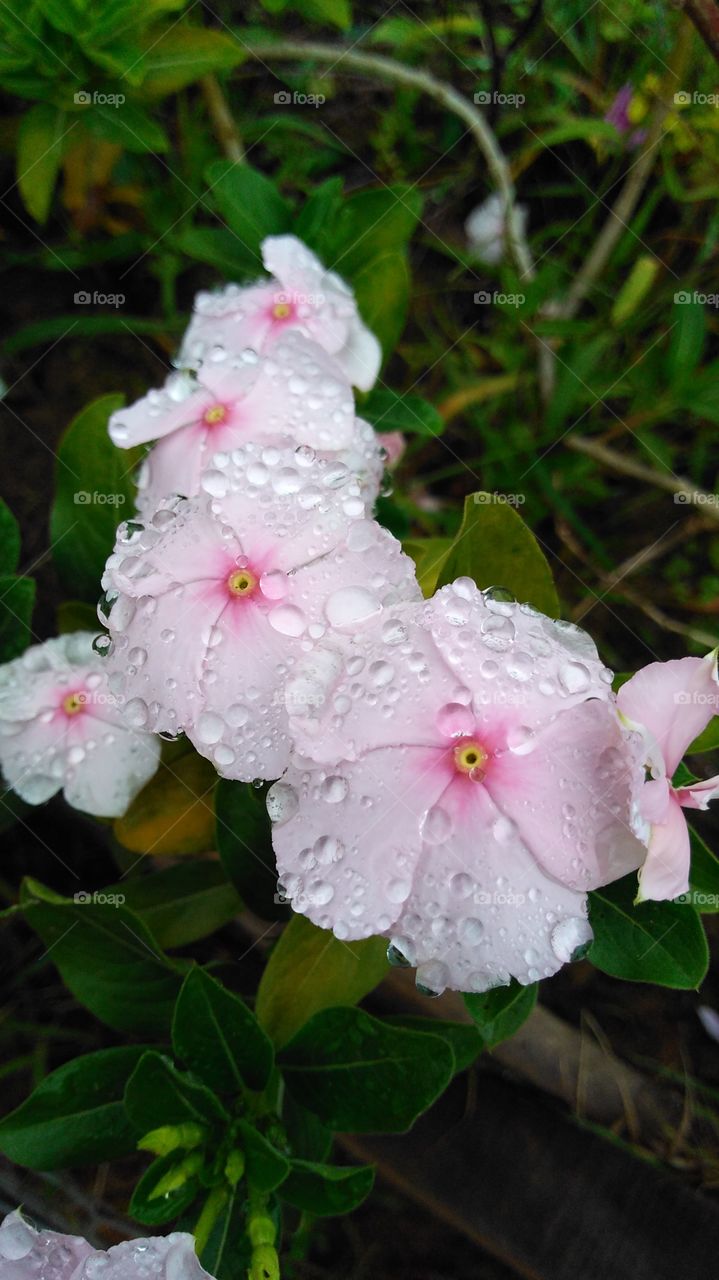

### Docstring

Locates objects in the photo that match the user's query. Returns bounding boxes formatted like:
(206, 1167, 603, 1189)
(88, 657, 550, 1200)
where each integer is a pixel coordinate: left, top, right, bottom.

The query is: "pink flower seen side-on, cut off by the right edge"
(617, 650, 719, 901)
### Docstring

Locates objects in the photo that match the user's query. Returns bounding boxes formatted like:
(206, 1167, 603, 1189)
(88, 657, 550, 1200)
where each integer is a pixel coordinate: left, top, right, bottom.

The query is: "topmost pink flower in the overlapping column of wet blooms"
(177, 236, 381, 392)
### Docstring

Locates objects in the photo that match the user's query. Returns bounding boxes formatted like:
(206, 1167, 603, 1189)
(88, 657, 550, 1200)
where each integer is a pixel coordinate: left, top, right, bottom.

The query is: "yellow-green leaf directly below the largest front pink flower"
(255, 915, 389, 1044)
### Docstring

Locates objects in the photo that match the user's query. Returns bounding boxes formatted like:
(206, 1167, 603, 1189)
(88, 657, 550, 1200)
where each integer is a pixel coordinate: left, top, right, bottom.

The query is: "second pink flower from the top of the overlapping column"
(109, 330, 356, 515)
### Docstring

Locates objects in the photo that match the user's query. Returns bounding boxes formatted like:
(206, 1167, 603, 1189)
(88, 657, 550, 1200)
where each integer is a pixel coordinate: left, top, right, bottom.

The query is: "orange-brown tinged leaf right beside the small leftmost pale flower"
(114, 750, 217, 858)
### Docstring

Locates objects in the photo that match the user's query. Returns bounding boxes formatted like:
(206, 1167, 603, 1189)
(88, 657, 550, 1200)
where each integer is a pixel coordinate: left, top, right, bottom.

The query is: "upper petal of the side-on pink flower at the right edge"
(617, 650, 719, 777)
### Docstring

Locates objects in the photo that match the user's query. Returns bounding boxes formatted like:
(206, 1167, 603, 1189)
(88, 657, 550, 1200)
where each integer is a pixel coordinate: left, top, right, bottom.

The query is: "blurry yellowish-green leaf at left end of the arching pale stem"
(139, 24, 247, 97)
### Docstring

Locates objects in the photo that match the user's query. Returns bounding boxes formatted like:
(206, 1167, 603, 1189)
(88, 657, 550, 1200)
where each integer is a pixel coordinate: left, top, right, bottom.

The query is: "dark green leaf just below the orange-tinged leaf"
(114, 860, 243, 950)
